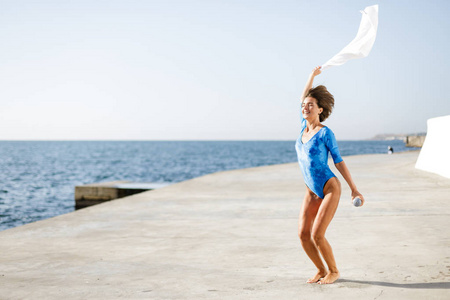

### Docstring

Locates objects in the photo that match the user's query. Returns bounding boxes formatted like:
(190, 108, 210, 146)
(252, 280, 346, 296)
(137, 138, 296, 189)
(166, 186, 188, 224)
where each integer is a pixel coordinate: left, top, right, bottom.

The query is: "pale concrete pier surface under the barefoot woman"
(0, 152, 450, 299)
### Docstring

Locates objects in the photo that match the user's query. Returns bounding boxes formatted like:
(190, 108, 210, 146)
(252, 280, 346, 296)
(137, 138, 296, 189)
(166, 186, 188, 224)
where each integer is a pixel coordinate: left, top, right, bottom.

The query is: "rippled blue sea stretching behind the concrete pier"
(0, 140, 415, 231)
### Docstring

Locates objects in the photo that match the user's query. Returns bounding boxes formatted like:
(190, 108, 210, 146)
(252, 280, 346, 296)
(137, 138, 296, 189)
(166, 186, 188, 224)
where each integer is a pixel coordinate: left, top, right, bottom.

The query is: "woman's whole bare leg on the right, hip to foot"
(312, 177, 341, 284)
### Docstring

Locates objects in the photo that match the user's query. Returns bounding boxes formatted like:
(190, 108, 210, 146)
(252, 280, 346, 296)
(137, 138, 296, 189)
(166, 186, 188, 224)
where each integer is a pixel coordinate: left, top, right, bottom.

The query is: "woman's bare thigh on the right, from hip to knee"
(312, 177, 341, 236)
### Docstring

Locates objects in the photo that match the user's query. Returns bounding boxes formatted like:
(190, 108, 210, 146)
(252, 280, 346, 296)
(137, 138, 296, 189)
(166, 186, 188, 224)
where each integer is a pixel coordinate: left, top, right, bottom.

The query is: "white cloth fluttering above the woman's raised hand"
(322, 5, 378, 70)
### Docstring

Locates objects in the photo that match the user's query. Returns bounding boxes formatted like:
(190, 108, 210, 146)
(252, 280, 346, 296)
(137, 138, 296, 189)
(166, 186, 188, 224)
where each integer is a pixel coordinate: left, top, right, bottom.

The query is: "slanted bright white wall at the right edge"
(416, 115, 450, 178)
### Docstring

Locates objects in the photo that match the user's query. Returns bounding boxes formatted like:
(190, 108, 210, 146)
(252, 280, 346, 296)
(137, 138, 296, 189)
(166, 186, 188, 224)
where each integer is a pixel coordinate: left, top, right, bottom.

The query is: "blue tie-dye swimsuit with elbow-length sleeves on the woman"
(295, 114, 343, 199)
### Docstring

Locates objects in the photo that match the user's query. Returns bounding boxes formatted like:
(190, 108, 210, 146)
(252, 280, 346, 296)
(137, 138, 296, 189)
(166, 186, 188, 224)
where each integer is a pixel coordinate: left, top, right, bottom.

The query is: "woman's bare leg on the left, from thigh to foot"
(298, 188, 327, 283)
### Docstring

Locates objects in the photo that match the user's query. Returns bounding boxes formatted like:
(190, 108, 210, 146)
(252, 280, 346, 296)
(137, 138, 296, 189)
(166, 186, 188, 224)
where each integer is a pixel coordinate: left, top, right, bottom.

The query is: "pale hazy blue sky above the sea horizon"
(0, 0, 450, 140)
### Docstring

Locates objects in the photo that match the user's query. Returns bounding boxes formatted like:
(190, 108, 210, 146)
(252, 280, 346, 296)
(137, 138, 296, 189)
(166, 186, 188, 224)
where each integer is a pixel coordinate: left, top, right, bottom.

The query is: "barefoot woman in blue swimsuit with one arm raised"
(295, 67, 364, 284)
